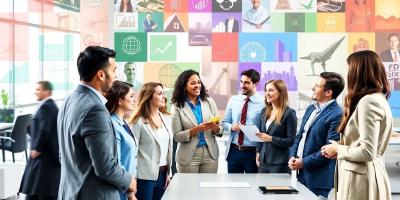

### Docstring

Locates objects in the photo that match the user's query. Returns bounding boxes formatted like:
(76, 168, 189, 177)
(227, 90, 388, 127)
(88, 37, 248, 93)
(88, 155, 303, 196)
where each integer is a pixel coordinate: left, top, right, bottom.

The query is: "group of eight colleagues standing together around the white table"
(21, 46, 392, 200)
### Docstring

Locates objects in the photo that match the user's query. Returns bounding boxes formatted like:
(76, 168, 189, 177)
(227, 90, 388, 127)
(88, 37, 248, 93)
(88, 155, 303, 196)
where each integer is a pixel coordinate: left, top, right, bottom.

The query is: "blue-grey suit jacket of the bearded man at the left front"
(57, 85, 132, 200)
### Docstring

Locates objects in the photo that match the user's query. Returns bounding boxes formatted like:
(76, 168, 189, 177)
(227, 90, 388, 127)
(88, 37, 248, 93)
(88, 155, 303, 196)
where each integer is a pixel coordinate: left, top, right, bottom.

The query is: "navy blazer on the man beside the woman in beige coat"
(290, 100, 342, 189)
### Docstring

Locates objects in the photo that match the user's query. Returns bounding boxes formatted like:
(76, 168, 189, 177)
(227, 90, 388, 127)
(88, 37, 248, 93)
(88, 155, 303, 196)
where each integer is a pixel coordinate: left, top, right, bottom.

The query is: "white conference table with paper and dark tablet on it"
(162, 173, 318, 200)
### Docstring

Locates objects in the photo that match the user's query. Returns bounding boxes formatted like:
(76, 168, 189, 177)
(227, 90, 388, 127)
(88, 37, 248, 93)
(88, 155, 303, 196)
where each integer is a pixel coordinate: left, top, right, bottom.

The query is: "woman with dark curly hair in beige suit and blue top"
(171, 70, 222, 173)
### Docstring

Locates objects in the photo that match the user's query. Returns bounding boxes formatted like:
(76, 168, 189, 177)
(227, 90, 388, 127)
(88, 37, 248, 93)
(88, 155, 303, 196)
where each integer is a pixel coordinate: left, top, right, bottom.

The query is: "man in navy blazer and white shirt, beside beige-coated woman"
(288, 72, 344, 197)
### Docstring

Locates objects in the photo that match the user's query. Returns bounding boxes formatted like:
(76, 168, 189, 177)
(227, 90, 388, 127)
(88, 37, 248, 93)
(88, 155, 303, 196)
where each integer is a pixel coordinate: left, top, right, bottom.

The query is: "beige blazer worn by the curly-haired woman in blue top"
(171, 97, 223, 165)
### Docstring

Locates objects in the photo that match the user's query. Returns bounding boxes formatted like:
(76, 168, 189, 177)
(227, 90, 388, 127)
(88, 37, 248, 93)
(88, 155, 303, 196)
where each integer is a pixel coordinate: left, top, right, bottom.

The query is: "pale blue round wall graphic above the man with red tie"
(240, 42, 266, 62)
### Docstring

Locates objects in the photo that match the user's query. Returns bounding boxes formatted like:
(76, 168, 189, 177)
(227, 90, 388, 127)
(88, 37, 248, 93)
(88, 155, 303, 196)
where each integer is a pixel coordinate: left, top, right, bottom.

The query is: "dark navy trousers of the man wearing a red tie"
(226, 148, 258, 173)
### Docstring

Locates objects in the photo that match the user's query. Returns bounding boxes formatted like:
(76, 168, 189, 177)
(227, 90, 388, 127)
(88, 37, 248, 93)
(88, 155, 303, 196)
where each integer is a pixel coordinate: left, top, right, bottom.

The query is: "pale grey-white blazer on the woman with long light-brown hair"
(132, 114, 172, 181)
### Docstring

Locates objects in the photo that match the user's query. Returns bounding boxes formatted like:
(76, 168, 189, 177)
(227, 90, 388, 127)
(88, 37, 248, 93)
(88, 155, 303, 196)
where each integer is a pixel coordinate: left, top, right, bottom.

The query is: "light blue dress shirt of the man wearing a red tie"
(222, 93, 265, 146)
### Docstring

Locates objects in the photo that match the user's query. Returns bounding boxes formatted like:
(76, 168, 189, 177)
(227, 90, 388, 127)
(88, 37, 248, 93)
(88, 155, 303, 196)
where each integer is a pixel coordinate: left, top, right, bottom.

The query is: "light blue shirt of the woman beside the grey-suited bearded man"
(111, 113, 137, 200)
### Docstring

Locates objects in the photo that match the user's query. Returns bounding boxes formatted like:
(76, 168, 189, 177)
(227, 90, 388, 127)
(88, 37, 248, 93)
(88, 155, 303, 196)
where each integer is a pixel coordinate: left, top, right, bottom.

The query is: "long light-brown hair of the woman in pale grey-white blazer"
(130, 82, 169, 128)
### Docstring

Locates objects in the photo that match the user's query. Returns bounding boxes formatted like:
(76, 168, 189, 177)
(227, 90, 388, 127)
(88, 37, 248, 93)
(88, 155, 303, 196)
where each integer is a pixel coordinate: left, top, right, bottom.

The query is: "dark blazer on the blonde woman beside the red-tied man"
(257, 107, 297, 165)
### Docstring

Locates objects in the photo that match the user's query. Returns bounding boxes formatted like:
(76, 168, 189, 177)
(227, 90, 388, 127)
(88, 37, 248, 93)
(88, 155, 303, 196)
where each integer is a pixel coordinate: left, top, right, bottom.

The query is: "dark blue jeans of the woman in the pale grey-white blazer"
(136, 171, 167, 200)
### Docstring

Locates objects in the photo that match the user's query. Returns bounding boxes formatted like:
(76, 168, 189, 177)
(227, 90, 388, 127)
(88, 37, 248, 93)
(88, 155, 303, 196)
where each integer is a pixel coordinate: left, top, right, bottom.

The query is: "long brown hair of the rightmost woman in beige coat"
(338, 50, 390, 133)
